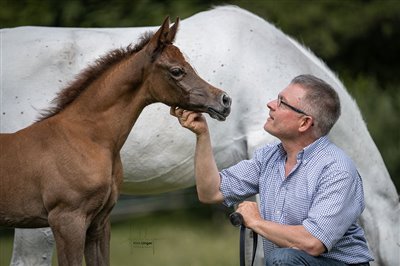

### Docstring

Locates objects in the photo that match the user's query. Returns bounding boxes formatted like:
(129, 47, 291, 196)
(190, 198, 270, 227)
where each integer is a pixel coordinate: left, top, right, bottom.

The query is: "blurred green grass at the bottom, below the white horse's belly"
(0, 207, 239, 266)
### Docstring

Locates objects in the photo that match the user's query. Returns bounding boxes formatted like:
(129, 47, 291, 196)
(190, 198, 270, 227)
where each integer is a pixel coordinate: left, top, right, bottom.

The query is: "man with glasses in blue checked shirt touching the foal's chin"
(171, 75, 373, 265)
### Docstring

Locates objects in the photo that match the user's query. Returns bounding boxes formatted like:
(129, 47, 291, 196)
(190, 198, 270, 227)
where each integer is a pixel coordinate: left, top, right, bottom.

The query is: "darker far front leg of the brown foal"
(85, 217, 111, 266)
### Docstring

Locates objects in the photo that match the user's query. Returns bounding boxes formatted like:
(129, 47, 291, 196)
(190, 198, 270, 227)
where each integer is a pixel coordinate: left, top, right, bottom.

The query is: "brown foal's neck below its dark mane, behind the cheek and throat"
(62, 55, 152, 151)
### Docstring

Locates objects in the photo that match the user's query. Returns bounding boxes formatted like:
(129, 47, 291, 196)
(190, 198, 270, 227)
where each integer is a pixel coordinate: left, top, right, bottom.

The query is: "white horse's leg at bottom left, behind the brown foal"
(10, 227, 55, 266)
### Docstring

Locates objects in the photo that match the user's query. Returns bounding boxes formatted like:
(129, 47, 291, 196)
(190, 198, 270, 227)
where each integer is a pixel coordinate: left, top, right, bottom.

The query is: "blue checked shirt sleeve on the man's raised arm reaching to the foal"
(220, 149, 263, 207)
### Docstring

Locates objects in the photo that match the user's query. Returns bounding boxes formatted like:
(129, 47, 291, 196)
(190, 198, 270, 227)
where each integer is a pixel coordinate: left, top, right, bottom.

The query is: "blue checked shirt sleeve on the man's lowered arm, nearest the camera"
(303, 170, 364, 251)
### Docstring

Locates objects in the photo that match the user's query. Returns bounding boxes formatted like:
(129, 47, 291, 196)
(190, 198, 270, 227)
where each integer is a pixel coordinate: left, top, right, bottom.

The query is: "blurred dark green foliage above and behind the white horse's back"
(0, 0, 400, 191)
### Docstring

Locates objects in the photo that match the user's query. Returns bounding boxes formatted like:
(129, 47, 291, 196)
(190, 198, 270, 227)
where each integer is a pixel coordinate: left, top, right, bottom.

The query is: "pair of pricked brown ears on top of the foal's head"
(146, 16, 179, 56)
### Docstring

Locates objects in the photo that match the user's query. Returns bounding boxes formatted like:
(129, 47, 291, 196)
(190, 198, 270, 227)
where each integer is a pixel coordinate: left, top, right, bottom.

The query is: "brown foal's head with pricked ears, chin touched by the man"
(142, 17, 231, 120)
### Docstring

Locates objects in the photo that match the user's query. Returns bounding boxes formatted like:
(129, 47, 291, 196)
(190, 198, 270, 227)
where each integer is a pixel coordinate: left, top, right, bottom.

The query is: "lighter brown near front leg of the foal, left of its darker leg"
(48, 210, 87, 266)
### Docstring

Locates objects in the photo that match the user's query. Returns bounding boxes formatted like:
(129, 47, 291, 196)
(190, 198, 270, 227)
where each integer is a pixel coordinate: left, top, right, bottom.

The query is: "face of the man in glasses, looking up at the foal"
(264, 84, 305, 140)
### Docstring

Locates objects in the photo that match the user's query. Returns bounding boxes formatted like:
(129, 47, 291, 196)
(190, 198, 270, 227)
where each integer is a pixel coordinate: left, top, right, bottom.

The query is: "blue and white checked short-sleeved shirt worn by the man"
(220, 136, 373, 264)
